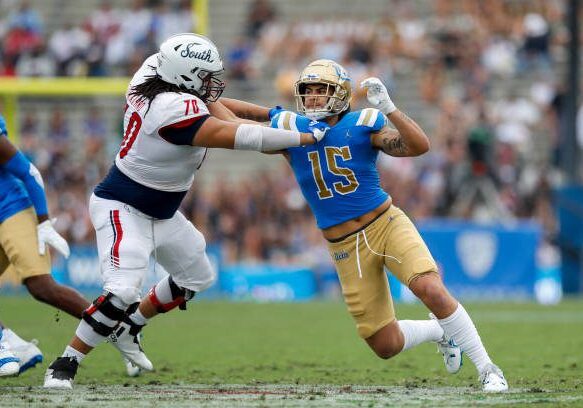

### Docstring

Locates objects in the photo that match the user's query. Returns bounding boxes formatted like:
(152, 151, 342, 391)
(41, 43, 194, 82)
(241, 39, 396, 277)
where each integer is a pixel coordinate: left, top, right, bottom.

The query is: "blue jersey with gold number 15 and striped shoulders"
(271, 108, 389, 229)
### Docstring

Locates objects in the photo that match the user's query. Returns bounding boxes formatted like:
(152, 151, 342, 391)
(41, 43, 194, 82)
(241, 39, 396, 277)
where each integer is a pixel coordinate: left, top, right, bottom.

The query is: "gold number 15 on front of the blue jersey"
(308, 146, 359, 200)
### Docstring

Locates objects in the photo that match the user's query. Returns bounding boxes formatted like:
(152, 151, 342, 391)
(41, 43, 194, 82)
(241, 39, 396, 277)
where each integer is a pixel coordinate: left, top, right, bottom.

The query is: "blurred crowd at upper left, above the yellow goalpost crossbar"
(0, 0, 189, 77)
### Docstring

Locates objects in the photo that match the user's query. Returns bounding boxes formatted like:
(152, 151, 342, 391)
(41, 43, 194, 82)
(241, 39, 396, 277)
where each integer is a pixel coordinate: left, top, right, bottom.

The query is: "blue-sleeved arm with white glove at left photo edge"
(0, 116, 70, 258)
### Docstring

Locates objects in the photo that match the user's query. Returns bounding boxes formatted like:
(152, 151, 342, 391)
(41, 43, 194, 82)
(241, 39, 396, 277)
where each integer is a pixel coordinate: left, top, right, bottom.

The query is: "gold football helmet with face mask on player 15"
(294, 59, 352, 120)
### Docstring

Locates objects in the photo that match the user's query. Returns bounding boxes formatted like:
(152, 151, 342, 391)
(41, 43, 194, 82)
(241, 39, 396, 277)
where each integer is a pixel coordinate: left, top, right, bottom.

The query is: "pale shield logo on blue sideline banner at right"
(456, 231, 498, 279)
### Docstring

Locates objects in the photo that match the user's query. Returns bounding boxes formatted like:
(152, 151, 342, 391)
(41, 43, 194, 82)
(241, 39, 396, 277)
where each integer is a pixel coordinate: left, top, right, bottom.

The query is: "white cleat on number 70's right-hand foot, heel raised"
(108, 318, 154, 376)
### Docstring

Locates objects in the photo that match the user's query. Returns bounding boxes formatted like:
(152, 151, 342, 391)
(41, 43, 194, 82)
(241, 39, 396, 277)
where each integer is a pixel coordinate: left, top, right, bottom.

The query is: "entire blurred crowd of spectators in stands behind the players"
(0, 0, 583, 266)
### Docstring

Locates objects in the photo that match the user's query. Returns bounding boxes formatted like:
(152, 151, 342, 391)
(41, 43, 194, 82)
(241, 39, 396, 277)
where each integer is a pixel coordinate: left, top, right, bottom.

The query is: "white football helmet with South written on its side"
(156, 33, 225, 102)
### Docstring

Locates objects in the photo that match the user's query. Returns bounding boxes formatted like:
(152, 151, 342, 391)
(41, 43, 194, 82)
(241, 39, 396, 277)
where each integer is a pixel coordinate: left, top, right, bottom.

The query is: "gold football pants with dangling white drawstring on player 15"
(328, 205, 437, 338)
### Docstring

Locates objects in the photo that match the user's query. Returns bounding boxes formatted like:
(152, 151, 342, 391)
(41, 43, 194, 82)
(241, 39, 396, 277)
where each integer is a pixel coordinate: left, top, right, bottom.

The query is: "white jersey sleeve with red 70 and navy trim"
(152, 94, 210, 145)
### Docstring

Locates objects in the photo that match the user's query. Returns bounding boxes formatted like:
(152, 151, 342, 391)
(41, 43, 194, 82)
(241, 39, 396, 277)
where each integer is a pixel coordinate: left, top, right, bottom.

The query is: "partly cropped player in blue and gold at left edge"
(0, 115, 71, 375)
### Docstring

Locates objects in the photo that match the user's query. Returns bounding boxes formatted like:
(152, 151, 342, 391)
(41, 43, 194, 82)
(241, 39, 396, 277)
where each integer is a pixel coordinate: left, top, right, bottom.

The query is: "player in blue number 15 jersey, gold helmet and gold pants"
(217, 60, 508, 392)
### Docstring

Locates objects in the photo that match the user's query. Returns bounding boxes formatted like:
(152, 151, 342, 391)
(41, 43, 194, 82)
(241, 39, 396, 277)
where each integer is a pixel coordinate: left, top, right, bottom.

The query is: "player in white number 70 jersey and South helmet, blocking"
(44, 33, 326, 389)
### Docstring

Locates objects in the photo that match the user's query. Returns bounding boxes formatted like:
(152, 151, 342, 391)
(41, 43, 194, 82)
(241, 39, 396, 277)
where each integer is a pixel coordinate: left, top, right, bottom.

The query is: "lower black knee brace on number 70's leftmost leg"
(82, 293, 129, 338)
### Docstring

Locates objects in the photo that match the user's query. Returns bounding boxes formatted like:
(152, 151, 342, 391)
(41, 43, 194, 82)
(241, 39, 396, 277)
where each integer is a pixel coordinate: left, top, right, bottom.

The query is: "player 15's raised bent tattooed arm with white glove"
(361, 78, 430, 157)
